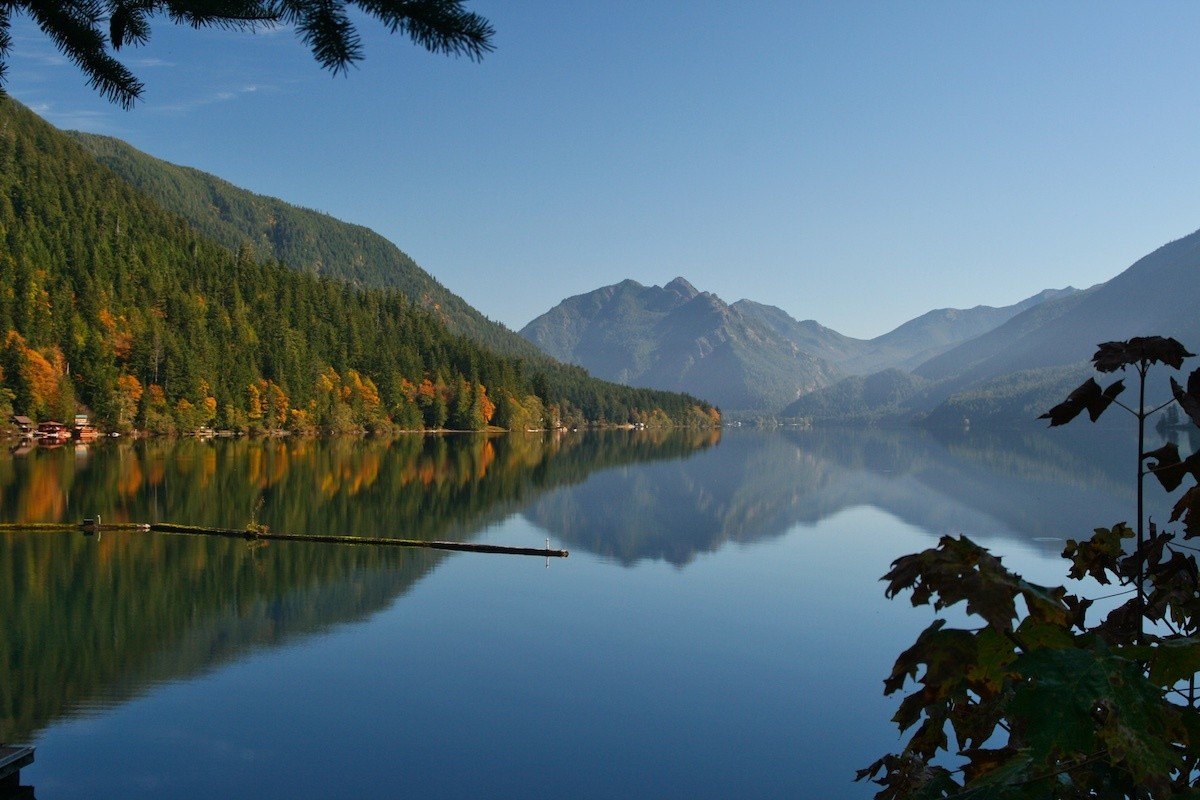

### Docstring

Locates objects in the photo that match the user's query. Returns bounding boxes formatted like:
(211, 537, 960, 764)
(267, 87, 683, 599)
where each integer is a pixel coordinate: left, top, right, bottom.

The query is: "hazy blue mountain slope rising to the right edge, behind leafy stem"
(785, 231, 1200, 426)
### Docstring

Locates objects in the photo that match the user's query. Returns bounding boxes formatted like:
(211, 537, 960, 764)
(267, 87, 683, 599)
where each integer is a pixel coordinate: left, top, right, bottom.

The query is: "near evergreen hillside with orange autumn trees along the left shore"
(0, 98, 716, 431)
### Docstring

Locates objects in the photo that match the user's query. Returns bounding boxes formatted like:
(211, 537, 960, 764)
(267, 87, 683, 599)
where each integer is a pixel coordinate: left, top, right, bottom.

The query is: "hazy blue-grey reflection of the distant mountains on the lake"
(524, 428, 1195, 566)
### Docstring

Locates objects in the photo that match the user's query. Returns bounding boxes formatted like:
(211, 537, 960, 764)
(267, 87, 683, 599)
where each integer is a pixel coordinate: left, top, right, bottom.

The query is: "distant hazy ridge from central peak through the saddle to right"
(521, 277, 1076, 413)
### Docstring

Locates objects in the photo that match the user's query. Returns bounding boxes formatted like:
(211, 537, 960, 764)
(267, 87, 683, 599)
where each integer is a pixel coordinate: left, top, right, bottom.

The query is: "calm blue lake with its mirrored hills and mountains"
(0, 425, 1196, 800)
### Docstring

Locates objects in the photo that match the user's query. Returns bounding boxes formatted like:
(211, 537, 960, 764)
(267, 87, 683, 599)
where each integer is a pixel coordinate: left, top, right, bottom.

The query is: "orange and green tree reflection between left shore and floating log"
(0, 431, 720, 539)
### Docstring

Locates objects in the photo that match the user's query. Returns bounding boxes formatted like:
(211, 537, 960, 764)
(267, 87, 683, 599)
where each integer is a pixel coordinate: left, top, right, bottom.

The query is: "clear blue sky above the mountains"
(6, 0, 1200, 336)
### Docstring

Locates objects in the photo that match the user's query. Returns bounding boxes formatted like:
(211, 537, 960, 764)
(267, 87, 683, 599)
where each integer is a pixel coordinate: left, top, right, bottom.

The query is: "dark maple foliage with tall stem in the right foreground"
(857, 337, 1200, 800)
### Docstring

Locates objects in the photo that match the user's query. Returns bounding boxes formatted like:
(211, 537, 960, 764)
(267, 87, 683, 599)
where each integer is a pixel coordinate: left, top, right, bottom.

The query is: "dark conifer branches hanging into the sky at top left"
(0, 0, 494, 108)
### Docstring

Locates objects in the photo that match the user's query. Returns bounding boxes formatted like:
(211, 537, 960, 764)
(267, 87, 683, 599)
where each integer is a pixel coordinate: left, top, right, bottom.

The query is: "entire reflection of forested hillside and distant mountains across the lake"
(0, 429, 1180, 796)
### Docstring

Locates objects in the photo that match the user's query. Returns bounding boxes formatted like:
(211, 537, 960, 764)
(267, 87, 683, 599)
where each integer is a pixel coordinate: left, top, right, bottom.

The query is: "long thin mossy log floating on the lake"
(0, 519, 570, 558)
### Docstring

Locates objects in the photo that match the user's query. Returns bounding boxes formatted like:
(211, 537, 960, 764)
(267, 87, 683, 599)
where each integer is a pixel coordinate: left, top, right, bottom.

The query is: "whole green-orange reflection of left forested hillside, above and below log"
(0, 432, 715, 741)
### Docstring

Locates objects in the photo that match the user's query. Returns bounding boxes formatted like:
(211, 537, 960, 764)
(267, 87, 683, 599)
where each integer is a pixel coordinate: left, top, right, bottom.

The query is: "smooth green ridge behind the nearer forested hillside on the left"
(68, 131, 536, 355)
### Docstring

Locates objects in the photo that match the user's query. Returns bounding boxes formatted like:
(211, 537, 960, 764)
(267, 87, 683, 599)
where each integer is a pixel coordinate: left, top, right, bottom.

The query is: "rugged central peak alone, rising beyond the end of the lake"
(521, 278, 840, 410)
